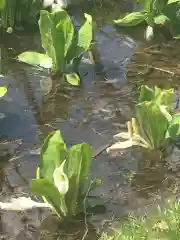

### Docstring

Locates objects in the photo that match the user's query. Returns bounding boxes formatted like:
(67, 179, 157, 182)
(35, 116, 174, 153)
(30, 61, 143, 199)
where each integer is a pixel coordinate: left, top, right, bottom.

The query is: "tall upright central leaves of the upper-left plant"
(39, 10, 74, 72)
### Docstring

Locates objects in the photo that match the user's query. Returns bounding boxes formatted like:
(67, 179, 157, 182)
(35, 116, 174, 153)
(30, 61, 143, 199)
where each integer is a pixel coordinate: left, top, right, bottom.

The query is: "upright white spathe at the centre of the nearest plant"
(53, 160, 69, 196)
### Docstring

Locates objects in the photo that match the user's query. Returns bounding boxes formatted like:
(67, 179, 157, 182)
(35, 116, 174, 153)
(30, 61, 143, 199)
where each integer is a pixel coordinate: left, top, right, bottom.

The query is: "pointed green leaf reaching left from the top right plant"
(114, 11, 147, 26)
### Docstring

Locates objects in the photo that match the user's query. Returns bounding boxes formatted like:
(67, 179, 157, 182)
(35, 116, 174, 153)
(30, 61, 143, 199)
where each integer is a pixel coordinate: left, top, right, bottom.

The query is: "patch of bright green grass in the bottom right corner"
(100, 201, 180, 240)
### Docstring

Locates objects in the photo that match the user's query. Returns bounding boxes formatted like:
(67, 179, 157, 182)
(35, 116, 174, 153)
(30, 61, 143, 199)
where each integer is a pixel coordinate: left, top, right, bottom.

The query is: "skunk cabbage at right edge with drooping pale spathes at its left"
(107, 86, 180, 151)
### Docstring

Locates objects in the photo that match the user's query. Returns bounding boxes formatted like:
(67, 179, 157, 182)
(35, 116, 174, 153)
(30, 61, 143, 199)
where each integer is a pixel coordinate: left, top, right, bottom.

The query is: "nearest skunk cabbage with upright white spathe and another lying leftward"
(0, 130, 102, 219)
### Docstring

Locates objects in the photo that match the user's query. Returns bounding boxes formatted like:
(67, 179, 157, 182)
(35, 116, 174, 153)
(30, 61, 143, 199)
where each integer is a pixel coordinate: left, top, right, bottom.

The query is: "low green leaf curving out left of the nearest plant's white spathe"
(30, 179, 63, 216)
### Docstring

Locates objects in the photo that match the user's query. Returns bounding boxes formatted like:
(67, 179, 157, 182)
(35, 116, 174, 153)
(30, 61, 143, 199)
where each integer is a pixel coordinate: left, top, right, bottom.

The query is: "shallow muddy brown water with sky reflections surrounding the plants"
(0, 3, 180, 240)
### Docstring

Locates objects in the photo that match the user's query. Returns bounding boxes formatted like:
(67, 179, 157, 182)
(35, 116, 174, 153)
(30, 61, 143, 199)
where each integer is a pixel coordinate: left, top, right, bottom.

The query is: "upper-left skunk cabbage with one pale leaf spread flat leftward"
(18, 9, 92, 85)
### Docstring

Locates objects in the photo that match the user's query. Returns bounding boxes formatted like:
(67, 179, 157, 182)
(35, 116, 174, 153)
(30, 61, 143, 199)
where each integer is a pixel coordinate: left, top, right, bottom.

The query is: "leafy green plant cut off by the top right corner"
(114, 0, 180, 40)
